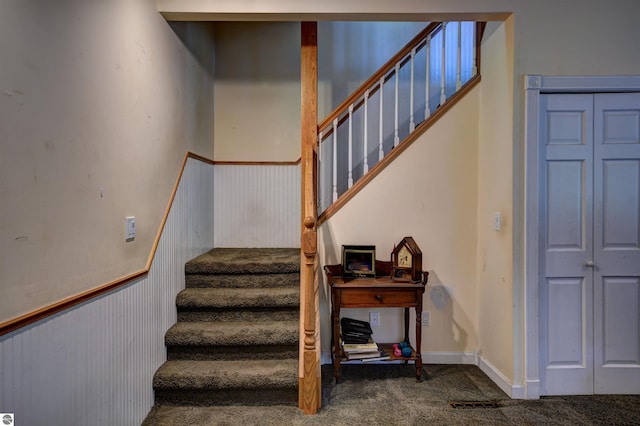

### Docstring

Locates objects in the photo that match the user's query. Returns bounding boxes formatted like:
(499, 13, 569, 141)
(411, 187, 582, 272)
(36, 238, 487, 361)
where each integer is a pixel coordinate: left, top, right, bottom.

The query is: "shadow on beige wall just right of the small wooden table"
(423, 270, 469, 350)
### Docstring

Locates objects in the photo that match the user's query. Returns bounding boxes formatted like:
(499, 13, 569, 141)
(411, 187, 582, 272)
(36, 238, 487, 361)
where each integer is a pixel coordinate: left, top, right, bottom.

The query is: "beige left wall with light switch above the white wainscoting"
(0, 0, 213, 322)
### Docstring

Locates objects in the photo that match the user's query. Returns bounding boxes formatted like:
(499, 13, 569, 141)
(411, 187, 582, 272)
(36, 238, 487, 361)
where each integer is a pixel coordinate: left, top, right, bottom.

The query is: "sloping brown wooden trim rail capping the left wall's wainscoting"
(0, 151, 214, 336)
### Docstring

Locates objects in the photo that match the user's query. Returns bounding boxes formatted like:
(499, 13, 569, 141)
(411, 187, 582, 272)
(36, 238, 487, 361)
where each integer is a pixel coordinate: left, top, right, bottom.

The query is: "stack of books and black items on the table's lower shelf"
(340, 318, 389, 361)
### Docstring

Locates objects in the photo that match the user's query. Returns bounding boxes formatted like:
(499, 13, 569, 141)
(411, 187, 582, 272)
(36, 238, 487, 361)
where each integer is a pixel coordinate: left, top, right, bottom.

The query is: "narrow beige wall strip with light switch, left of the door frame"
(477, 18, 514, 378)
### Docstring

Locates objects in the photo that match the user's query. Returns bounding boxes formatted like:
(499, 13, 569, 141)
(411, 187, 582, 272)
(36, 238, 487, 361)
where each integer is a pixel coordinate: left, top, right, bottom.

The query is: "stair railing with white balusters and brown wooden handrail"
(318, 22, 483, 221)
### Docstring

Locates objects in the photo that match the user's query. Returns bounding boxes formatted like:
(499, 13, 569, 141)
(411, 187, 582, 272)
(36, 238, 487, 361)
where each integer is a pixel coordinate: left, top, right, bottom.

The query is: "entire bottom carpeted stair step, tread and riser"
(153, 359, 298, 406)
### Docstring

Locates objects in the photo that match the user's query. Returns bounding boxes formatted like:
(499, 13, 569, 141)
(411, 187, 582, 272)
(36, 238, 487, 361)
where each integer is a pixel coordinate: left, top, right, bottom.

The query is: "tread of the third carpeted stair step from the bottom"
(176, 287, 300, 310)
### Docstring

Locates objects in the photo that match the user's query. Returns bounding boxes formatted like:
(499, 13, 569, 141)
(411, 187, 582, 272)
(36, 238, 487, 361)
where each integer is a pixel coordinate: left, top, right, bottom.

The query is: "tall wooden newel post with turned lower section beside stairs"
(298, 22, 322, 414)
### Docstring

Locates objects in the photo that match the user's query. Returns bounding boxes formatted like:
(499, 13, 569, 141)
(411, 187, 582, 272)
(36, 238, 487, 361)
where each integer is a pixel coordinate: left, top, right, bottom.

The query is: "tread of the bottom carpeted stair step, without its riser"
(153, 359, 298, 390)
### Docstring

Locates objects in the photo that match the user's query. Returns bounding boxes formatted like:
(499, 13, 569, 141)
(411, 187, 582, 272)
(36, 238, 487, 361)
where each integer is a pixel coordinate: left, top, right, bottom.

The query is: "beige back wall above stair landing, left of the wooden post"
(214, 22, 300, 161)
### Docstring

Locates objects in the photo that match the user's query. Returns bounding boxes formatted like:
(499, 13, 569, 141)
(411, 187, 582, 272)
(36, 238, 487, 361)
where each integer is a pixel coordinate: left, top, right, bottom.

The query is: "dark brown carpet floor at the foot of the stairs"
(144, 364, 640, 426)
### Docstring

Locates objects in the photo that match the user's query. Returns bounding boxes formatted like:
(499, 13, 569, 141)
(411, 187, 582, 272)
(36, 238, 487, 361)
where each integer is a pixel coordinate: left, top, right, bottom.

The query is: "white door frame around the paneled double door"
(514, 75, 640, 399)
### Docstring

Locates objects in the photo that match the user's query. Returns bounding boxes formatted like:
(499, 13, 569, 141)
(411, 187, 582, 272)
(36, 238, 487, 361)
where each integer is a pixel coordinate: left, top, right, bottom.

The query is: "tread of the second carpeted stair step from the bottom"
(165, 321, 300, 349)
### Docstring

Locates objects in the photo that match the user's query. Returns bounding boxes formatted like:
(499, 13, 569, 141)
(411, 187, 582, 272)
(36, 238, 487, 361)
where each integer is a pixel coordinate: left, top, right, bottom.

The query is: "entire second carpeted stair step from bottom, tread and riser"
(165, 321, 300, 360)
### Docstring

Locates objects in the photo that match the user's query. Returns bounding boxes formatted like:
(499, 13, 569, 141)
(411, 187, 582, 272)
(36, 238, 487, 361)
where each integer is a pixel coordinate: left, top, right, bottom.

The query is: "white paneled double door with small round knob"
(539, 93, 640, 395)
